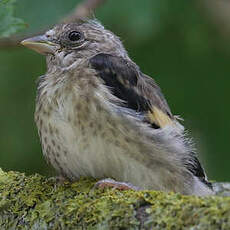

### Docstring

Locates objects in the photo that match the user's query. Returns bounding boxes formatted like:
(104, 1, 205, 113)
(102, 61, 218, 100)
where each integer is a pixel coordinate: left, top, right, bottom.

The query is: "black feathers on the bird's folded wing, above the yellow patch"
(90, 54, 150, 112)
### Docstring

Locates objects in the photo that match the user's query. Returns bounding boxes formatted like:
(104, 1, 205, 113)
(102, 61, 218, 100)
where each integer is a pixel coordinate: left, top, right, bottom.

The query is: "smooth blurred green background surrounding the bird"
(0, 0, 230, 181)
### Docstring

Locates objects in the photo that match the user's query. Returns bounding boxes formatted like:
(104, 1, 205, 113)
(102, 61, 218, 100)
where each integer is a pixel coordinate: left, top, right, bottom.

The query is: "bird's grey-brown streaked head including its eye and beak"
(21, 20, 127, 67)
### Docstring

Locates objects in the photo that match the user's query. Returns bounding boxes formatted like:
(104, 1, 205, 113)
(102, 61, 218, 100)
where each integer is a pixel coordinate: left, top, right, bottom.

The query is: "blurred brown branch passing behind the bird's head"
(0, 0, 106, 48)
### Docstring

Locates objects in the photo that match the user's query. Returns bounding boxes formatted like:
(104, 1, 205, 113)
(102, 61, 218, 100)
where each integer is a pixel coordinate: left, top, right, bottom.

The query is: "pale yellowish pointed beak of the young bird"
(21, 35, 57, 54)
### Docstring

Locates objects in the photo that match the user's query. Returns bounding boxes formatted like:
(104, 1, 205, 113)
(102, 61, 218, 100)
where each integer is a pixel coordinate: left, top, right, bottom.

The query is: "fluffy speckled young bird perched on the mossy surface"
(21, 19, 213, 196)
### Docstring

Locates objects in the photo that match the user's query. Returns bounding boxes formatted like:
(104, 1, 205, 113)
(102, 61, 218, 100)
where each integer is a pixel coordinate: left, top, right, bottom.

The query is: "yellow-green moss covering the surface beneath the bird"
(0, 170, 230, 230)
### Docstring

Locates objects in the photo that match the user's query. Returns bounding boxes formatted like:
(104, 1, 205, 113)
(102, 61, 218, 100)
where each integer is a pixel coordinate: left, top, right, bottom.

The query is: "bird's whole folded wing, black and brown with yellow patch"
(89, 53, 175, 128)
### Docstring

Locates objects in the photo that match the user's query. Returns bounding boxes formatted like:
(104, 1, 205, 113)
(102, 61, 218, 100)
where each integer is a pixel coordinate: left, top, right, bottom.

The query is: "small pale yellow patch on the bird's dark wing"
(147, 107, 173, 128)
